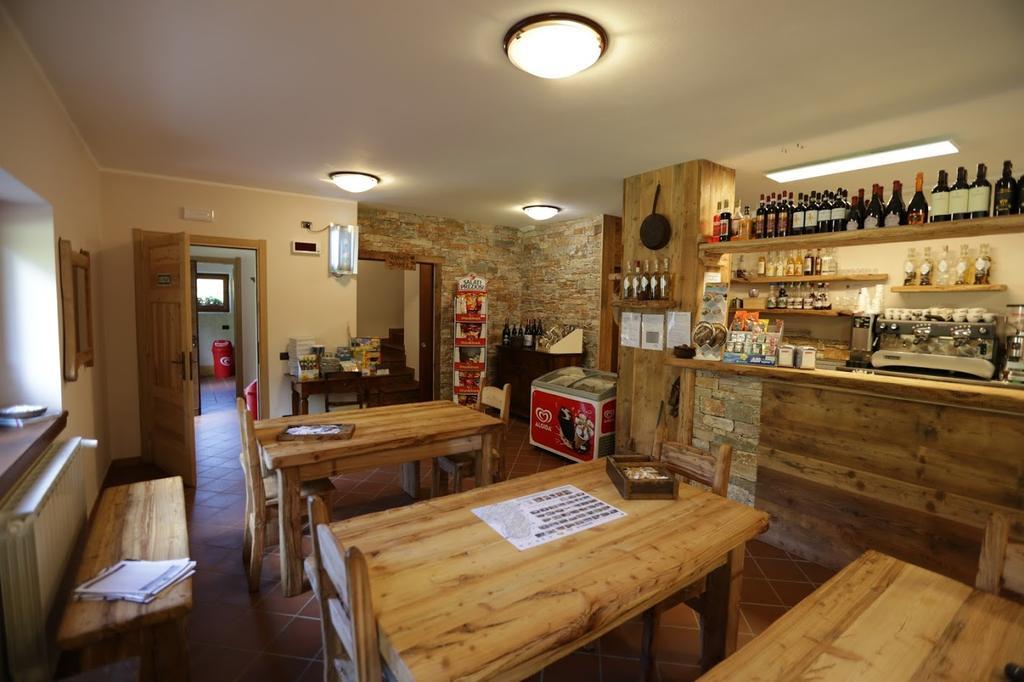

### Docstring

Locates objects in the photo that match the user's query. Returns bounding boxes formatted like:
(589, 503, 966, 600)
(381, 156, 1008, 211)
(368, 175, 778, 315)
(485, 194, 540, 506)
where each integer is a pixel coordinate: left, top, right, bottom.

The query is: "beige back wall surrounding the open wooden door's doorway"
(99, 172, 356, 457)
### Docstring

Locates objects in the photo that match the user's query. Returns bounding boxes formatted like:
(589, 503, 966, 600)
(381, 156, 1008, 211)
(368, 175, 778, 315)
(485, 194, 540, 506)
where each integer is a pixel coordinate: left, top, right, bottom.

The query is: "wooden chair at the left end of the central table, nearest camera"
(305, 497, 393, 682)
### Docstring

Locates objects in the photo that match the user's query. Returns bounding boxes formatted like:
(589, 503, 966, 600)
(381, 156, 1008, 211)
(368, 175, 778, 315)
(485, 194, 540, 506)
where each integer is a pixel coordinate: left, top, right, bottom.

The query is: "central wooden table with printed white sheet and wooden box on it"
(321, 461, 768, 680)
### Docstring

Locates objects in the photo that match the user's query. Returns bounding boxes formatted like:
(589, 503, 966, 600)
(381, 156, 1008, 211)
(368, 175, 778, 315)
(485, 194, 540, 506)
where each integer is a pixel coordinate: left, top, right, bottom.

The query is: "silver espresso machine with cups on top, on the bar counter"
(868, 318, 1001, 380)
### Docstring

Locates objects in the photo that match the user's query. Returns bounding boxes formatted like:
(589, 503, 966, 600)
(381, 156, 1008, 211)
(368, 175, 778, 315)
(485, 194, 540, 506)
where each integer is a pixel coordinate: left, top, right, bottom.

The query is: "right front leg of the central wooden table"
(700, 544, 745, 672)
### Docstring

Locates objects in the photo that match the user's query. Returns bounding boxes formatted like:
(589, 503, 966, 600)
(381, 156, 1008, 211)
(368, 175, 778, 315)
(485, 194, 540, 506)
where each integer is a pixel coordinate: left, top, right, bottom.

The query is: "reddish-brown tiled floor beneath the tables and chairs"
(101, 381, 833, 682)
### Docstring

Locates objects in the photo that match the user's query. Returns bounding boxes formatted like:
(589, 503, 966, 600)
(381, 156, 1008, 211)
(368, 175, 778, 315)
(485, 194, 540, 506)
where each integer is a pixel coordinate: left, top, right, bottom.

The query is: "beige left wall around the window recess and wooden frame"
(0, 7, 111, 503)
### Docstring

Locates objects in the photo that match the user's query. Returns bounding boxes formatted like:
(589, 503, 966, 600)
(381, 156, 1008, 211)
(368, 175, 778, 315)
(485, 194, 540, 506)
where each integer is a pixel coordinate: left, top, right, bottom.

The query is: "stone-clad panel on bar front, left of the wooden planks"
(693, 372, 761, 506)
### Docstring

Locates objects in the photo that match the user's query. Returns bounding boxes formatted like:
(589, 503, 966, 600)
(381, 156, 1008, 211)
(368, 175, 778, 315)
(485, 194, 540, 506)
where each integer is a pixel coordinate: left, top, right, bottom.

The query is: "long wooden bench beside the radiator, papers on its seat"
(57, 476, 193, 680)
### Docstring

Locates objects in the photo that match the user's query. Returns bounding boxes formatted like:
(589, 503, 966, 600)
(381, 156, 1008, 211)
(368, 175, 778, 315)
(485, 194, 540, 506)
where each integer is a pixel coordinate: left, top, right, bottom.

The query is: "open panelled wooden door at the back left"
(133, 229, 199, 486)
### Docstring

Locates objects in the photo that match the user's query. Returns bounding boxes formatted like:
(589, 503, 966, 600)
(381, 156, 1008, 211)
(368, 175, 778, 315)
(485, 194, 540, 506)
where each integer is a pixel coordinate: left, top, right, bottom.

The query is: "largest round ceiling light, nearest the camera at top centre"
(505, 12, 608, 78)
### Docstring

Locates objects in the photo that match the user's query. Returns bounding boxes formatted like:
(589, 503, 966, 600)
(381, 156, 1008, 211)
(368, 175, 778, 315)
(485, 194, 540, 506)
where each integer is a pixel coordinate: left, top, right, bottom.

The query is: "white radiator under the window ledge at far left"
(0, 437, 96, 682)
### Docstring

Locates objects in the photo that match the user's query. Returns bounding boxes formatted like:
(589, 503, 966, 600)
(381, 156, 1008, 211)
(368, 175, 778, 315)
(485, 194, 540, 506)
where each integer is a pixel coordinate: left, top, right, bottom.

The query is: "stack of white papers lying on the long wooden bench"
(75, 558, 196, 604)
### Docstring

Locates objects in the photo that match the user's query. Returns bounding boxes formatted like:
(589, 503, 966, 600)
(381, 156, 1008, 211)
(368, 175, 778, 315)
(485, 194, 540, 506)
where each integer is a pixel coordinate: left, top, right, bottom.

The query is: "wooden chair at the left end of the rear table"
(238, 398, 334, 592)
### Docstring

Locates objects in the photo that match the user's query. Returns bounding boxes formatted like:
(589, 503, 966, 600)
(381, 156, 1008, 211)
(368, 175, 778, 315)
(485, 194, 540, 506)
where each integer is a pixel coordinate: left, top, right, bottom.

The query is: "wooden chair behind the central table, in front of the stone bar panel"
(640, 421, 732, 680)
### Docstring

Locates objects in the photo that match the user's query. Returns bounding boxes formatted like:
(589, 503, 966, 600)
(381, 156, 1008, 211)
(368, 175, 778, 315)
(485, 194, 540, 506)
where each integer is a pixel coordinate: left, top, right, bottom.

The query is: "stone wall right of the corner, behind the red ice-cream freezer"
(519, 216, 604, 367)
